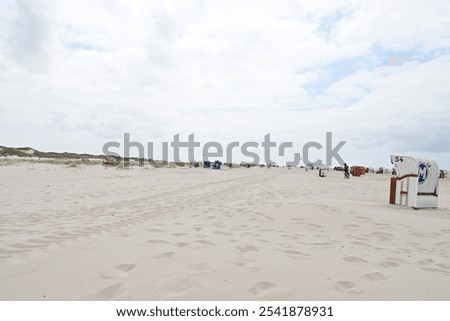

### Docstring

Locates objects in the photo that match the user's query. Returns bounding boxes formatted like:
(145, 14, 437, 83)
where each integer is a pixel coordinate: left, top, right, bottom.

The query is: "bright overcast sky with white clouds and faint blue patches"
(0, 0, 450, 169)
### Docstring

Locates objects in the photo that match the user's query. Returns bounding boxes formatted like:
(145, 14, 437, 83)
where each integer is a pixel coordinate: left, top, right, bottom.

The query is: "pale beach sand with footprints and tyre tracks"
(0, 162, 450, 300)
